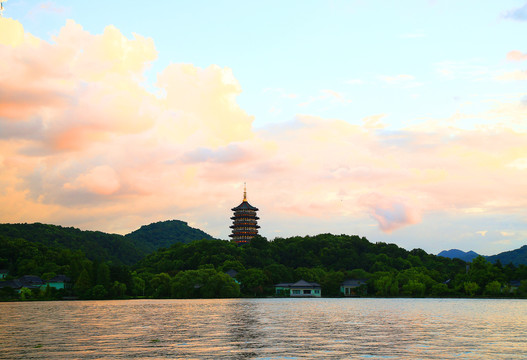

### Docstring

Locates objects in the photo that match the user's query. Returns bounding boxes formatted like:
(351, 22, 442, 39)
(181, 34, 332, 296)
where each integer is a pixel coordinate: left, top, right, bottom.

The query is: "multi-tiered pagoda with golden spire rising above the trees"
(229, 186, 260, 244)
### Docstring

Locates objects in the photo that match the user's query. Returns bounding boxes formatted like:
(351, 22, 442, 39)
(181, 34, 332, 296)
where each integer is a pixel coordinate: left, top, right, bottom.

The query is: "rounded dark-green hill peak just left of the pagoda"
(125, 220, 214, 254)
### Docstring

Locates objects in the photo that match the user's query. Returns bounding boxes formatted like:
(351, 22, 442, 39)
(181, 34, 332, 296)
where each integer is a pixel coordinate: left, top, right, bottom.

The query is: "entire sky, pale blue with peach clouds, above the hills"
(0, 0, 527, 255)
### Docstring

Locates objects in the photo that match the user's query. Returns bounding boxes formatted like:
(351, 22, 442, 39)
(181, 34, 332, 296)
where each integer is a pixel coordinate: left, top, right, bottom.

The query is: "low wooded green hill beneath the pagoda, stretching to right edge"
(134, 234, 527, 297)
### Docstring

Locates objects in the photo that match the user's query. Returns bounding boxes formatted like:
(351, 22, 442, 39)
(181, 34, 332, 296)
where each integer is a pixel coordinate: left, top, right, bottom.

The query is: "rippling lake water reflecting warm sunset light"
(0, 299, 527, 359)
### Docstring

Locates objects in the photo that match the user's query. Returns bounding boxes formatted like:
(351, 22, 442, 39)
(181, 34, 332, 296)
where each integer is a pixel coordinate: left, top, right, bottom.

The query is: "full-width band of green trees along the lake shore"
(0, 234, 527, 299)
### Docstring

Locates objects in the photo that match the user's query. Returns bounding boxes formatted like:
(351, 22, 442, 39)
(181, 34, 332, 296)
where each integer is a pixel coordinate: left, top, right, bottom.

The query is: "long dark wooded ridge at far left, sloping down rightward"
(0, 223, 146, 265)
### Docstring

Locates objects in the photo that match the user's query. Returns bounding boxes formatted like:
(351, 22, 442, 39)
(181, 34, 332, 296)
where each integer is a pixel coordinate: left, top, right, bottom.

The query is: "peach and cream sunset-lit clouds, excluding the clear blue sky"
(0, 1, 527, 252)
